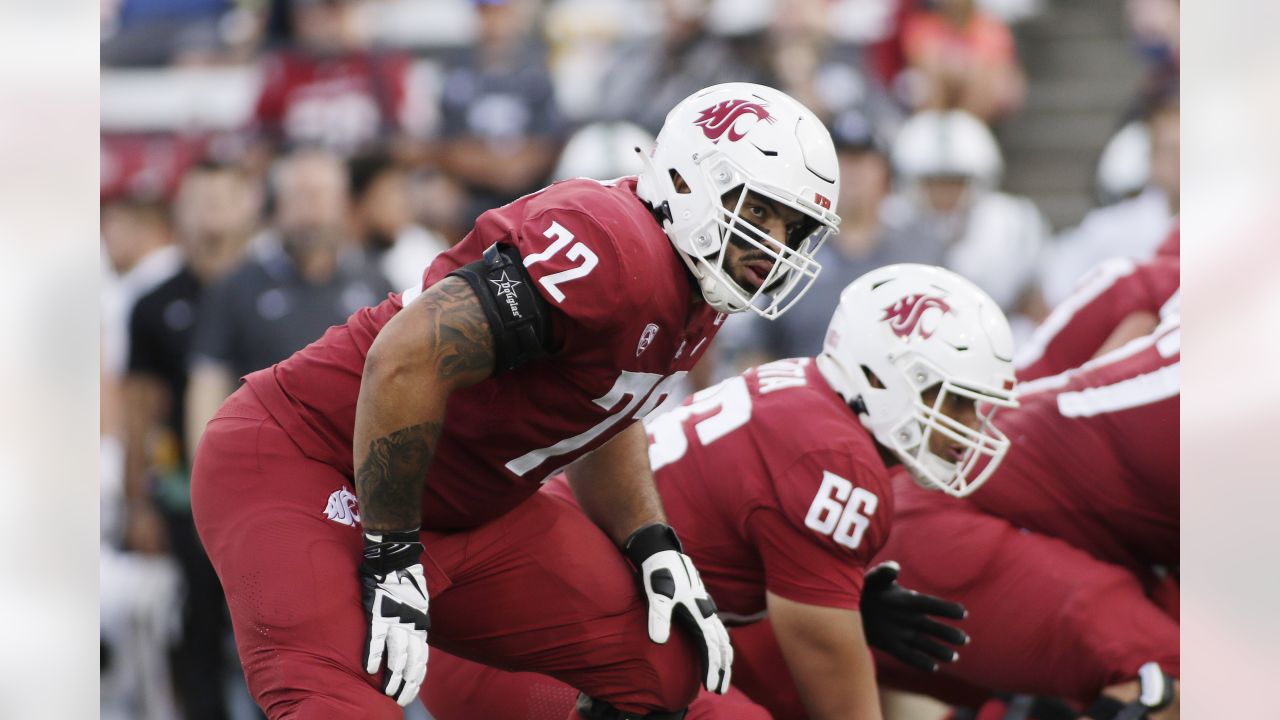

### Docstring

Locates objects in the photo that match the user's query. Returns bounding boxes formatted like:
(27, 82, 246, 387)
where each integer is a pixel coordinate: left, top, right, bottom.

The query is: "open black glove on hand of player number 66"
(860, 561, 969, 673)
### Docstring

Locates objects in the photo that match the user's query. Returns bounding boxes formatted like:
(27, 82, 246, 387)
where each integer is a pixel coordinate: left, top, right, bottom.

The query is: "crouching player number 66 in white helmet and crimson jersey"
(424, 264, 1014, 720)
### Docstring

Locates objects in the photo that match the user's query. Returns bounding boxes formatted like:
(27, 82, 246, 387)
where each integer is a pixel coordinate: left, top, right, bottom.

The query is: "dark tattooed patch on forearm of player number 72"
(356, 423, 440, 530)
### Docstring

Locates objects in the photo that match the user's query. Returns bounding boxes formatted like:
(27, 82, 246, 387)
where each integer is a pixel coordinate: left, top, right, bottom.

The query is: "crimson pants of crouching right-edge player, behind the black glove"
(874, 489, 1180, 703)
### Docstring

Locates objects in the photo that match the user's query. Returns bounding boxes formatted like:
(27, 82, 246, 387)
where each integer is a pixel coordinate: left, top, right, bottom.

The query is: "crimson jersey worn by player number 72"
(246, 178, 723, 529)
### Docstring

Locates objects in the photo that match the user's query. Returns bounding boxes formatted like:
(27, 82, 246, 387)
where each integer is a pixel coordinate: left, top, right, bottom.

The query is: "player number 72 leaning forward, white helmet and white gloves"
(192, 83, 838, 717)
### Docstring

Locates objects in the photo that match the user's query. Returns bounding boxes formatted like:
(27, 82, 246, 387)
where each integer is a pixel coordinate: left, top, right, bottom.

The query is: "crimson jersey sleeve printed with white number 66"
(746, 452, 893, 610)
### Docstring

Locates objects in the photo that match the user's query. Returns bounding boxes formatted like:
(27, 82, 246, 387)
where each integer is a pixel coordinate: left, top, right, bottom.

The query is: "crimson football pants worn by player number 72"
(192, 387, 701, 720)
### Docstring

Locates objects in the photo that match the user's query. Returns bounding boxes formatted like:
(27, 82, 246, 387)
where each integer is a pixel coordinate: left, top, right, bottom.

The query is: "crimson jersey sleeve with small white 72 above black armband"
(507, 209, 644, 333)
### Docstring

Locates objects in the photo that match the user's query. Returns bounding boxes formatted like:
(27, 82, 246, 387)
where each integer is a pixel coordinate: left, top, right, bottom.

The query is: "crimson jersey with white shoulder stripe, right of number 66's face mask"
(968, 314, 1181, 573)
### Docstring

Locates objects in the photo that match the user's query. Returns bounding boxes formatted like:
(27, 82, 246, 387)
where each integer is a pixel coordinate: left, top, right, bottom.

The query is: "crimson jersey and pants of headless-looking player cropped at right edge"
(870, 315, 1180, 702)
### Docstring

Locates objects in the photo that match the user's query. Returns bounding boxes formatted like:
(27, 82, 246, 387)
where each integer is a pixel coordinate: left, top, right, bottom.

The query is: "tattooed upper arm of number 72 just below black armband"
(403, 277, 494, 386)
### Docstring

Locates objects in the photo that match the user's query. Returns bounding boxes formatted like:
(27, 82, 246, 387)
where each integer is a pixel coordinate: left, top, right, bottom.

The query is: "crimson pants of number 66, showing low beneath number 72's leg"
(422, 648, 772, 720)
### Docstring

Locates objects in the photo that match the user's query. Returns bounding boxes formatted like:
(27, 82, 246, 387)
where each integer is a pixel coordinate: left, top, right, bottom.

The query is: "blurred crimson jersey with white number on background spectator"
(253, 51, 426, 154)
